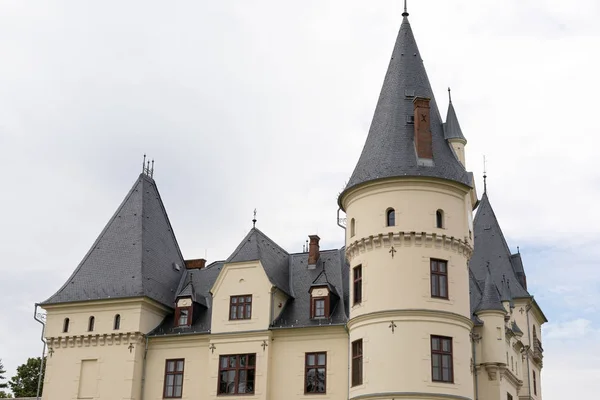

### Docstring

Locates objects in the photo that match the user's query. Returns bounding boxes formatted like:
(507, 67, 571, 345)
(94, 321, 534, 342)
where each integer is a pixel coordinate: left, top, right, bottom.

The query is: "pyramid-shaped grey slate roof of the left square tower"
(43, 174, 185, 307)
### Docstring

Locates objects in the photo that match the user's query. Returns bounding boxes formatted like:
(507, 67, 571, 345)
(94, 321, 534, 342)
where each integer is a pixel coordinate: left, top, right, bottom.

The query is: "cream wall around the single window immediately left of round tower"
(268, 326, 348, 400)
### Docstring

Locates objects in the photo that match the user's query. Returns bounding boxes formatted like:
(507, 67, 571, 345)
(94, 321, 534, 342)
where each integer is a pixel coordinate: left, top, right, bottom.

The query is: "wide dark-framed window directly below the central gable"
(219, 354, 256, 394)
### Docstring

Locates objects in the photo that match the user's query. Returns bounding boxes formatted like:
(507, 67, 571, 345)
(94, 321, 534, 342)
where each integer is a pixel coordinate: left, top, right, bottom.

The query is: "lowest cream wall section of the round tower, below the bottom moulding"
(349, 311, 473, 399)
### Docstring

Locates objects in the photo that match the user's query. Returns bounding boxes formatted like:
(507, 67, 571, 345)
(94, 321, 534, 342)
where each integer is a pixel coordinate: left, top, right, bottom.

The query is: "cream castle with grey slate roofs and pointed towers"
(42, 7, 547, 400)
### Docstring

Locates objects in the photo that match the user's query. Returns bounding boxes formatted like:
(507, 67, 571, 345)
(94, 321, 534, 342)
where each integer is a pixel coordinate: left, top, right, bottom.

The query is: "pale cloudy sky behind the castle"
(0, 0, 600, 400)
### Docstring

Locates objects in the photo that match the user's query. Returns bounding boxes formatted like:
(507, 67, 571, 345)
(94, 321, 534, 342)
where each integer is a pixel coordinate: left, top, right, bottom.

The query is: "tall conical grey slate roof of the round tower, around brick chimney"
(340, 15, 471, 206)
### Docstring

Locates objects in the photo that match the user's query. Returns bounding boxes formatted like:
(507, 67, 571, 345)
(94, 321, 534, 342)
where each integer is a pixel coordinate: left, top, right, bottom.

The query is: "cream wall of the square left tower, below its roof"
(43, 298, 168, 400)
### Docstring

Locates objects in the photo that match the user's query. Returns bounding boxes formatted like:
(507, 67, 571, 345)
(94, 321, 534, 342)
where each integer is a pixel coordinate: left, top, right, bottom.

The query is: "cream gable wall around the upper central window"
(211, 261, 273, 333)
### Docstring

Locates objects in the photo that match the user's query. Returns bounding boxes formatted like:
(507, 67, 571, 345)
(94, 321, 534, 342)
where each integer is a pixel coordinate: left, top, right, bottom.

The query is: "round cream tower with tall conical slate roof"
(338, 11, 476, 400)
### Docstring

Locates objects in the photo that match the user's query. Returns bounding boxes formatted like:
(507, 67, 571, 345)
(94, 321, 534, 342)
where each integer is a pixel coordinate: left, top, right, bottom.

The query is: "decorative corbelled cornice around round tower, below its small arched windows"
(346, 231, 473, 258)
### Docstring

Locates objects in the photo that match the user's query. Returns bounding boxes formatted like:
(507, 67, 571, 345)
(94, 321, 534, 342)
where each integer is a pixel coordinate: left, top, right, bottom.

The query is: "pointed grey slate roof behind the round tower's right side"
(469, 193, 530, 299)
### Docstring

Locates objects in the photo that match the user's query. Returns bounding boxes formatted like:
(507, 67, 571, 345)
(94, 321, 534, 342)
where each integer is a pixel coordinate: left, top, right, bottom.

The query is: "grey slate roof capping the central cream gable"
(226, 228, 290, 295)
